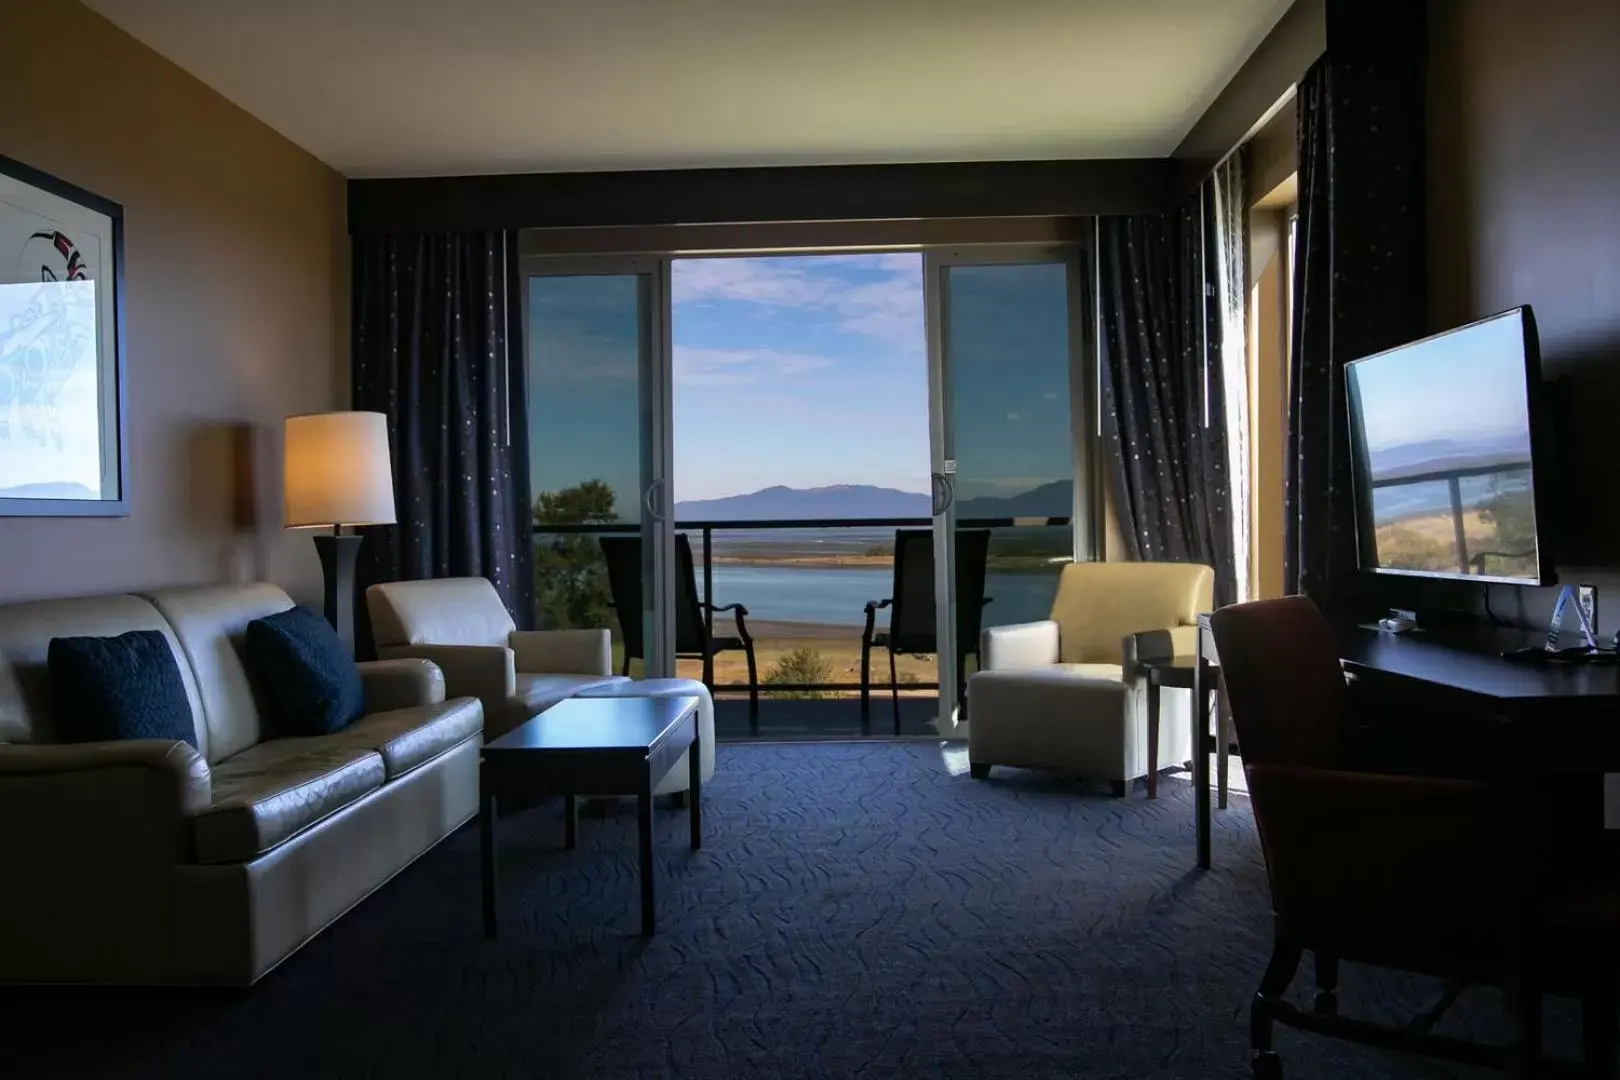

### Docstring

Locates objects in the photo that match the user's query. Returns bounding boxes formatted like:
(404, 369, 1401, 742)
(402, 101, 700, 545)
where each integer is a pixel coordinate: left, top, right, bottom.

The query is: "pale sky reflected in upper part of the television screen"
(1351, 317, 1529, 450)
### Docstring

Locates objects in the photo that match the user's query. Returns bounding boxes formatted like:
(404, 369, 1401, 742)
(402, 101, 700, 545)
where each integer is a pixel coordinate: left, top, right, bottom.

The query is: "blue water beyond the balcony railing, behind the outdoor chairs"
(698, 563, 1058, 627)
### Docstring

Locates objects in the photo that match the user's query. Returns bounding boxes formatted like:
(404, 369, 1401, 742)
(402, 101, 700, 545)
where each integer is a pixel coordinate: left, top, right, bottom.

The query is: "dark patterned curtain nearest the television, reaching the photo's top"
(1283, 3, 1427, 609)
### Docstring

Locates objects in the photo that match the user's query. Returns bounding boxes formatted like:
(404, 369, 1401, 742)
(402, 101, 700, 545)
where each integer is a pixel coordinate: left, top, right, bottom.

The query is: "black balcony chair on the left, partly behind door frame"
(601, 533, 760, 733)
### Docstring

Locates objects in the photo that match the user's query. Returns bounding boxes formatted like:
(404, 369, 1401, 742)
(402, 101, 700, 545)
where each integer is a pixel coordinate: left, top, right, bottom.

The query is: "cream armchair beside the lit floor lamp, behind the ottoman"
(366, 578, 624, 742)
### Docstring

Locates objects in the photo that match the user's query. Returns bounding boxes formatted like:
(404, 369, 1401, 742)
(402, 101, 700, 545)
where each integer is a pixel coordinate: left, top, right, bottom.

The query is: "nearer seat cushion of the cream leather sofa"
(193, 737, 386, 863)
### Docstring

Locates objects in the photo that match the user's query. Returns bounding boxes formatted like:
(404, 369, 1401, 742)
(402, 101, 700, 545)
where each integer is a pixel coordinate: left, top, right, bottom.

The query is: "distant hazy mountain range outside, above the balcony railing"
(676, 479, 1074, 521)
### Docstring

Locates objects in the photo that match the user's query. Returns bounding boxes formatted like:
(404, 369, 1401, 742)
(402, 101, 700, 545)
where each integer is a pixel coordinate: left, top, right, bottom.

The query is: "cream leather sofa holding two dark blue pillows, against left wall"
(0, 585, 483, 986)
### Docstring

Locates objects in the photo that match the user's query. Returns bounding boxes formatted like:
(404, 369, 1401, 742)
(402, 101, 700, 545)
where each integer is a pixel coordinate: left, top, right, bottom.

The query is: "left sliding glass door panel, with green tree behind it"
(523, 257, 676, 677)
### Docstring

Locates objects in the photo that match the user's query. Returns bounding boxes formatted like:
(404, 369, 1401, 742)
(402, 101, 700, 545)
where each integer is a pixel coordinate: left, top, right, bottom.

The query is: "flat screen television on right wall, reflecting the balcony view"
(1345, 306, 1554, 585)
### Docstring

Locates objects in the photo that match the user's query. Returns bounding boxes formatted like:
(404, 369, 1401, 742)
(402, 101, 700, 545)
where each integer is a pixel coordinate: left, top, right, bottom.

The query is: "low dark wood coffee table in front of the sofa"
(478, 698, 703, 938)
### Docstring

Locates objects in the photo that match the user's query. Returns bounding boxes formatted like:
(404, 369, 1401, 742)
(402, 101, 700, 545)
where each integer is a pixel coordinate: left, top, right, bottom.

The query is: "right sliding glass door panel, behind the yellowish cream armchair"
(925, 248, 1095, 735)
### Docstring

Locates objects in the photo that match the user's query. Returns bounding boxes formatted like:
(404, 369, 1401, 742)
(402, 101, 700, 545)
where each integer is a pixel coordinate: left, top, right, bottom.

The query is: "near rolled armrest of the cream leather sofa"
(0, 738, 214, 861)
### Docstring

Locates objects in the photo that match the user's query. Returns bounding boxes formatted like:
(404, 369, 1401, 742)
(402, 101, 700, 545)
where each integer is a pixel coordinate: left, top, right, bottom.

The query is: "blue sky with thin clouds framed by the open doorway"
(672, 254, 928, 499)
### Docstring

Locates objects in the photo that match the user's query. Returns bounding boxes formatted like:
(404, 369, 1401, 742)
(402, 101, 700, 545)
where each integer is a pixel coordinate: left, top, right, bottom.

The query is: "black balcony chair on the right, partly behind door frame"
(860, 529, 991, 735)
